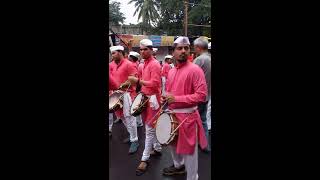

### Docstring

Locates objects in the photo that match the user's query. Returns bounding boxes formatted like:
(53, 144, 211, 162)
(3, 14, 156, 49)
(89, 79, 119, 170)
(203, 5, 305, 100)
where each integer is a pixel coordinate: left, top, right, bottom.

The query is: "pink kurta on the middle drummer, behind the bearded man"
(141, 57, 161, 127)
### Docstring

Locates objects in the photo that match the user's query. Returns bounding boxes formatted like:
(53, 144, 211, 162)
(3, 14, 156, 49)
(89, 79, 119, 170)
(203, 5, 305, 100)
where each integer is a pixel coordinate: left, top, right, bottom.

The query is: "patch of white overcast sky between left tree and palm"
(111, 0, 141, 24)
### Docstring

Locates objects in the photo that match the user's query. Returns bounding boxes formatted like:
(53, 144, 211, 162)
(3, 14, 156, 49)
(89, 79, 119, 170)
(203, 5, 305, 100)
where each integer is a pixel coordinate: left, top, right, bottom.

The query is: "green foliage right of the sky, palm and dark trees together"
(129, 0, 214, 37)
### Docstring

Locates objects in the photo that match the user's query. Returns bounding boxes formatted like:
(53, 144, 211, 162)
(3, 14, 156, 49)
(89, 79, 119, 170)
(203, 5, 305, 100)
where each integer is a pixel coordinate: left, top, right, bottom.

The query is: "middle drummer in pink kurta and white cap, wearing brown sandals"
(129, 39, 161, 176)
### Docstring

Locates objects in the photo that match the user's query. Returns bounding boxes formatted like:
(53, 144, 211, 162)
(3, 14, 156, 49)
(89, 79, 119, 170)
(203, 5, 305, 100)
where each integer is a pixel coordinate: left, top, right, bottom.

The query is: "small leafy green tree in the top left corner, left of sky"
(109, 1, 126, 25)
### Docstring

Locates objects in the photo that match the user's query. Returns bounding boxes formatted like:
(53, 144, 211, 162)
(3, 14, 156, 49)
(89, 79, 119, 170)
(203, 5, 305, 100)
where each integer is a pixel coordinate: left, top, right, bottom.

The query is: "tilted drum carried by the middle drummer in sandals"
(130, 92, 149, 117)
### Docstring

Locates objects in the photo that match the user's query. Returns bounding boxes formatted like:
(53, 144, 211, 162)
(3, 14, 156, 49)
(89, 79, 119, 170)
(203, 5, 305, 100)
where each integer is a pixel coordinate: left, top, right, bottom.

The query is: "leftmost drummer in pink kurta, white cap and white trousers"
(109, 46, 139, 154)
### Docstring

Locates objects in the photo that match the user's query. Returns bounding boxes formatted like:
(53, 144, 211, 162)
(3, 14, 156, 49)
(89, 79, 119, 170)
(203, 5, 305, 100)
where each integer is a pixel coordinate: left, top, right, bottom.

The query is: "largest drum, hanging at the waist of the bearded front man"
(156, 112, 179, 145)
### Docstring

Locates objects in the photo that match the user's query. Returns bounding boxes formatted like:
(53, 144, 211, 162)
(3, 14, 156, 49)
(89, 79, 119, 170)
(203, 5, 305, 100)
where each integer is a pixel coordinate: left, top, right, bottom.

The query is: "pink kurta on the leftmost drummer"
(109, 59, 138, 118)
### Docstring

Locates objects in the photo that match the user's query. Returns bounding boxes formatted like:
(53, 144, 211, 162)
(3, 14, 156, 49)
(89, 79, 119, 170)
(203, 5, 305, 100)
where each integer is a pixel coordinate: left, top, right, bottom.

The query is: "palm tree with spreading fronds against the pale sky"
(128, 0, 159, 32)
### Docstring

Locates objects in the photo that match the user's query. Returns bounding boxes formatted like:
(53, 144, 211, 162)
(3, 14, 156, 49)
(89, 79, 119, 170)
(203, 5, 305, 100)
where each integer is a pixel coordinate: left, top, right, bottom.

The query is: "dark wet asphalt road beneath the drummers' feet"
(109, 118, 211, 180)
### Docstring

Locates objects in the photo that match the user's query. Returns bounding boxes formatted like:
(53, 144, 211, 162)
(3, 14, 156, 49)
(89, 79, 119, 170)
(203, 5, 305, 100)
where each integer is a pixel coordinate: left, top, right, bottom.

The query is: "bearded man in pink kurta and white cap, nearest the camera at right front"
(162, 37, 207, 180)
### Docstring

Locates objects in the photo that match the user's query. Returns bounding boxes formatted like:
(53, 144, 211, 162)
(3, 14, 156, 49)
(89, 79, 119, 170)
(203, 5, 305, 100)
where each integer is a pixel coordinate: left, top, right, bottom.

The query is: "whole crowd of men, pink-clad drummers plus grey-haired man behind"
(109, 36, 211, 180)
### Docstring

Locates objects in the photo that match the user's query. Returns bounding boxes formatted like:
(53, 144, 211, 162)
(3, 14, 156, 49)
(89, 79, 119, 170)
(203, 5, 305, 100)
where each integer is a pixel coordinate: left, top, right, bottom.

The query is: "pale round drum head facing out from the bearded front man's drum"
(156, 113, 171, 144)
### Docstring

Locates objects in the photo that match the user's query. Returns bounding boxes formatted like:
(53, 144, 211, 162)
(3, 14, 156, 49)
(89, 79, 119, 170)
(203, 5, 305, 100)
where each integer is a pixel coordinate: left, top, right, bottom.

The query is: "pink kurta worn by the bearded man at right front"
(166, 62, 208, 154)
